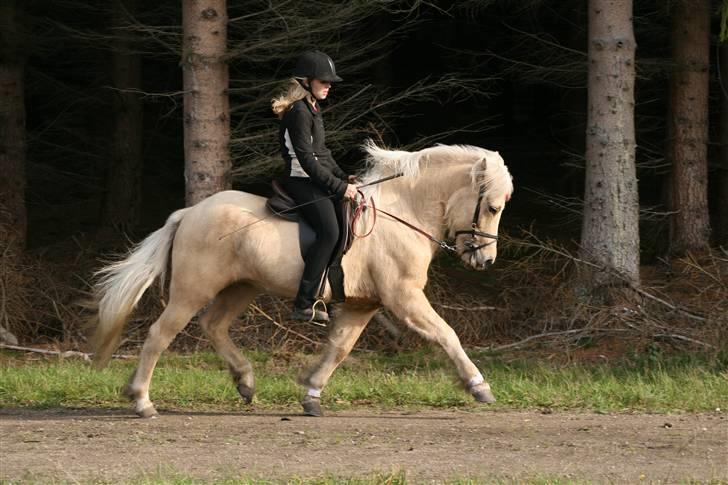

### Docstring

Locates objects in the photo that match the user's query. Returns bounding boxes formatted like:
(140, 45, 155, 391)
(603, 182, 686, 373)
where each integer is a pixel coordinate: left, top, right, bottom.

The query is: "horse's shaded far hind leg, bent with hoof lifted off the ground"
(200, 284, 258, 404)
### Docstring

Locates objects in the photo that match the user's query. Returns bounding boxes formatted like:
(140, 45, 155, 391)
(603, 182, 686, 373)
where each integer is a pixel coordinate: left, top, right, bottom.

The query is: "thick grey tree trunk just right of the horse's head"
(580, 0, 639, 296)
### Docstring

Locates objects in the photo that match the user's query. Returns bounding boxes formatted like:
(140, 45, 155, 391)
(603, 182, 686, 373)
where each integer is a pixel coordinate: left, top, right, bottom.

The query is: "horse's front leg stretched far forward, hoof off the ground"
(384, 288, 495, 403)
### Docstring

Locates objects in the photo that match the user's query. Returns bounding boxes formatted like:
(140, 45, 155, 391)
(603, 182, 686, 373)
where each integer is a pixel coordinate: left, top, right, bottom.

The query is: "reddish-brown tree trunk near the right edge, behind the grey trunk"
(667, 0, 710, 255)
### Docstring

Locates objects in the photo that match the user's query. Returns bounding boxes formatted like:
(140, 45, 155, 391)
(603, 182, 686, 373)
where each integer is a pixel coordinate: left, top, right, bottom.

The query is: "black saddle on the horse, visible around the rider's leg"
(265, 180, 354, 301)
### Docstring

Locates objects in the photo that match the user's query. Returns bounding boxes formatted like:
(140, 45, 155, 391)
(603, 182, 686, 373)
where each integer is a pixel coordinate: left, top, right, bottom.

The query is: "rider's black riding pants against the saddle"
(282, 177, 339, 308)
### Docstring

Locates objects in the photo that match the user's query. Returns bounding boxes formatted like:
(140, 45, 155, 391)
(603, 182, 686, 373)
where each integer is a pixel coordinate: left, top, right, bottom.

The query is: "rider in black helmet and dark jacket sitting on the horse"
(272, 51, 357, 323)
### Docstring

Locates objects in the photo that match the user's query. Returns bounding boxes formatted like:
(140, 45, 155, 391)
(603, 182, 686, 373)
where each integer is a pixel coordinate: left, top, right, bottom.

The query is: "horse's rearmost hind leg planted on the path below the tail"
(124, 291, 207, 418)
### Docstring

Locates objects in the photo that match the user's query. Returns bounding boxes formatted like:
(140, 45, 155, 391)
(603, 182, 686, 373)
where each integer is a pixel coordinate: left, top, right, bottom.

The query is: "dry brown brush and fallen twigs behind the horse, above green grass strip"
(0, 223, 728, 355)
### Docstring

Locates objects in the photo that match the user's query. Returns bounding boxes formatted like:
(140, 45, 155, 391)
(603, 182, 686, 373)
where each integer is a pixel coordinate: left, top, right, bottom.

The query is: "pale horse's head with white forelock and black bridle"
(447, 150, 513, 270)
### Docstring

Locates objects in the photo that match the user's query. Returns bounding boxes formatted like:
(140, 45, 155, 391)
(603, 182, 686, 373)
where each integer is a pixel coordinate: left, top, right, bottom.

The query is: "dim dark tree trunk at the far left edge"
(0, 0, 28, 254)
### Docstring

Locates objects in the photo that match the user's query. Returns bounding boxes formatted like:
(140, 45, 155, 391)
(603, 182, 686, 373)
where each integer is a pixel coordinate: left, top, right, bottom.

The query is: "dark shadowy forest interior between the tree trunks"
(3, 0, 728, 348)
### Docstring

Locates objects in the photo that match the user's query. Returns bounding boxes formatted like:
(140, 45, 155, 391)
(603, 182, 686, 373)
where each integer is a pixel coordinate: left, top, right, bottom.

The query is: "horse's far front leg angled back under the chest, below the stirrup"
(300, 304, 378, 416)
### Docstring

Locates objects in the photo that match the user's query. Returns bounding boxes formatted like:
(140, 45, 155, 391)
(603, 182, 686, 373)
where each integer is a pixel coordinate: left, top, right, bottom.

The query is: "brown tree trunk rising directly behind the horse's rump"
(182, 0, 232, 206)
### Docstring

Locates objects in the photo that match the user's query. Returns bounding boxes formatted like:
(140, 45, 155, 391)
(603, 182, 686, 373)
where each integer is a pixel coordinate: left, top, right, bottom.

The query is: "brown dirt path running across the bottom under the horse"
(0, 409, 728, 483)
